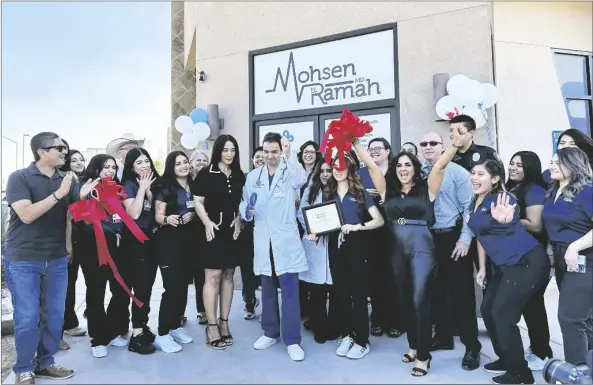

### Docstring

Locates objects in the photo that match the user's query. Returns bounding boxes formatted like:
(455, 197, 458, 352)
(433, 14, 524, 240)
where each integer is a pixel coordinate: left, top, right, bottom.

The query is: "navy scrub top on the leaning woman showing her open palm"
(468, 194, 539, 267)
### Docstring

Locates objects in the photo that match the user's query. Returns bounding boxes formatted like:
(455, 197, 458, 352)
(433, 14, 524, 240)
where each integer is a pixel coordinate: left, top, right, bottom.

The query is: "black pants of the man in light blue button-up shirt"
(433, 228, 482, 351)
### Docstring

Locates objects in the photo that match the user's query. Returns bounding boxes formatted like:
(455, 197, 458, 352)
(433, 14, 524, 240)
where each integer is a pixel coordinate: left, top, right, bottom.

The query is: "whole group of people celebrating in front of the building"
(6, 115, 593, 384)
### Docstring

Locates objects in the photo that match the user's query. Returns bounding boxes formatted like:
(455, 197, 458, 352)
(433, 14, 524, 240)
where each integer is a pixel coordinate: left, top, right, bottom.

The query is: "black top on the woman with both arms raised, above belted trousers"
(383, 179, 434, 226)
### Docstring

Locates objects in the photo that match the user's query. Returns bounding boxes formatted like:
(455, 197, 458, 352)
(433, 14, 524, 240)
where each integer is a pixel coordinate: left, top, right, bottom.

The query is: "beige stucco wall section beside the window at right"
(493, 2, 593, 166)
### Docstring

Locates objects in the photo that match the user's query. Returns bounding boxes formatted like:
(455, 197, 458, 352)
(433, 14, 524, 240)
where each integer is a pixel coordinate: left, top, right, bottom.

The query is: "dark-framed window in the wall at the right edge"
(554, 51, 593, 135)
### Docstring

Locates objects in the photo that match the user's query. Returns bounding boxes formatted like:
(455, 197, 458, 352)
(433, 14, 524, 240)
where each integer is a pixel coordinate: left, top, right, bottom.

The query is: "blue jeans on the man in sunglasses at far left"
(6, 257, 68, 374)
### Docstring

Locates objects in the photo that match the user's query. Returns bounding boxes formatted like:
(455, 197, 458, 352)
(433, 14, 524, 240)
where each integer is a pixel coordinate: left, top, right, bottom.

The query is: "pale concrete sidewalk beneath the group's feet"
(5, 271, 563, 384)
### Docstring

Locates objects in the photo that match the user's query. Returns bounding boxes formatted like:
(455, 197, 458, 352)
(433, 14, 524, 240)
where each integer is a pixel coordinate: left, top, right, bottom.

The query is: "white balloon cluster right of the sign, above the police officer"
(436, 75, 498, 128)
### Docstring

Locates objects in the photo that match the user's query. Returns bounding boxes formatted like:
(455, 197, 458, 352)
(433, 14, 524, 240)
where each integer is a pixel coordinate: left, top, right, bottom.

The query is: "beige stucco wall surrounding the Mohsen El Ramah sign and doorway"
(185, 2, 495, 168)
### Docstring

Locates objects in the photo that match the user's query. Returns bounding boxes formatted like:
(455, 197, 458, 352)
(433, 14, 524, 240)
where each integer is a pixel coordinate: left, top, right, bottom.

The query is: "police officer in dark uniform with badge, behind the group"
(449, 115, 506, 180)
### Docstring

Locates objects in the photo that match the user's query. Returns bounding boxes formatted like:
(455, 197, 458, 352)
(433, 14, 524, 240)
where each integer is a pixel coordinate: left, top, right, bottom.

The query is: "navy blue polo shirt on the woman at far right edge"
(542, 185, 593, 246)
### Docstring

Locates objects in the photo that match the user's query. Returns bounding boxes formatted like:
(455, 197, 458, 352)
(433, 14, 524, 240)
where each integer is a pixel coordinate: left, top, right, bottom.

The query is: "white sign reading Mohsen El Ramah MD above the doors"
(253, 30, 395, 115)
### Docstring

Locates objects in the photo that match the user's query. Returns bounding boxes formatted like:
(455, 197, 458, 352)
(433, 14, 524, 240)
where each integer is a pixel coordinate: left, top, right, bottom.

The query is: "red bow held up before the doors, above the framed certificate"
(321, 108, 373, 171)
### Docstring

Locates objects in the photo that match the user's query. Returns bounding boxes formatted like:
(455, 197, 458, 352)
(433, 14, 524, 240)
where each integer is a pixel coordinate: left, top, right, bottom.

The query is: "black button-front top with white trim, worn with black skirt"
(192, 165, 245, 229)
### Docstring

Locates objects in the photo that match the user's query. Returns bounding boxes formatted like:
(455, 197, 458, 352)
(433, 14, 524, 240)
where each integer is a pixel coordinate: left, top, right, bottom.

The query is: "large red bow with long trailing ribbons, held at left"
(68, 177, 148, 307)
